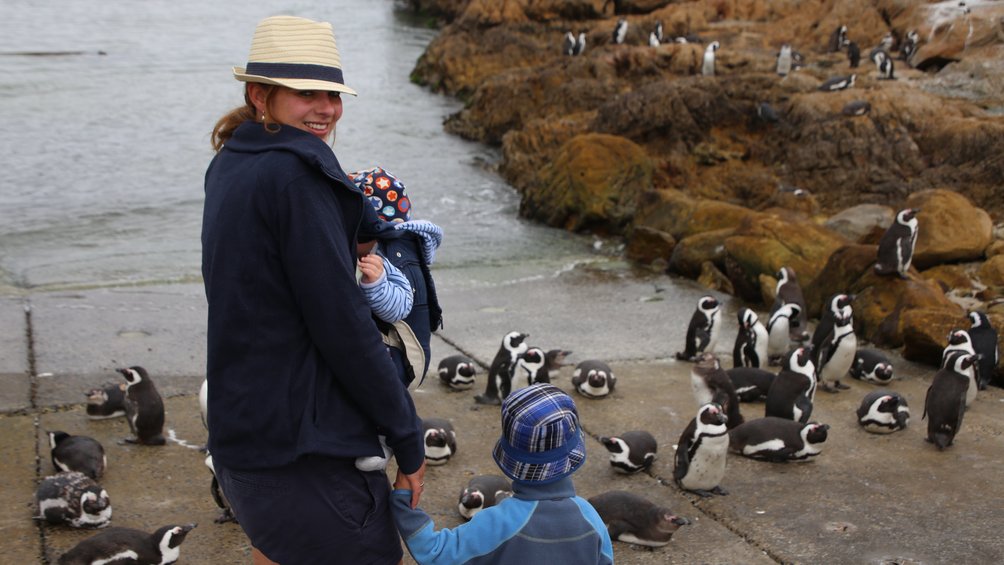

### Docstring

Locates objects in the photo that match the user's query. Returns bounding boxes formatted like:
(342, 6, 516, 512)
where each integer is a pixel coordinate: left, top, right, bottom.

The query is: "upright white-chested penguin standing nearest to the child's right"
(673, 403, 729, 498)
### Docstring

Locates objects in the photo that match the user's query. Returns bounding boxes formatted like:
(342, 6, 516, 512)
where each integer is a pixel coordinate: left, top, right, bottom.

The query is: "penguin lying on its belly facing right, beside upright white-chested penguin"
(729, 416, 829, 463)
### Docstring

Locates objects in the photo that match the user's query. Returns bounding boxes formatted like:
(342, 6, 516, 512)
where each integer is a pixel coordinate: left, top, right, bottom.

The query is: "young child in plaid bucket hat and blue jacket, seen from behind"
(391, 383, 613, 565)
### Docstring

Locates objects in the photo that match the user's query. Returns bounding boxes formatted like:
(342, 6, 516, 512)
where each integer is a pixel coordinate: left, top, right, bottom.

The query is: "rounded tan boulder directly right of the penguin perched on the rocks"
(906, 189, 993, 269)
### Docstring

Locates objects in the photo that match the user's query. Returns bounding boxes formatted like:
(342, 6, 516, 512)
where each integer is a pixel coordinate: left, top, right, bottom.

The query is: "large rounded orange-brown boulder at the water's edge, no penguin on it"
(520, 133, 653, 234)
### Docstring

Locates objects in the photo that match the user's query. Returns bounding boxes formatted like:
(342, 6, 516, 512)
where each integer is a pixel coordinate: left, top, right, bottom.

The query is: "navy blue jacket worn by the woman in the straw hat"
(202, 121, 425, 473)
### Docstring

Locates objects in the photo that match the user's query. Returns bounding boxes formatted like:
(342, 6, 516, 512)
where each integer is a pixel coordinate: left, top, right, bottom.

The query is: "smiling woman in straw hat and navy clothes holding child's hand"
(202, 16, 425, 565)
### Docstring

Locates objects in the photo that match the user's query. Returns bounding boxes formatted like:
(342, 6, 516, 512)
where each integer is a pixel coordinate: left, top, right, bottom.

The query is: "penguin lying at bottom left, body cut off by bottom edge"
(59, 524, 196, 565)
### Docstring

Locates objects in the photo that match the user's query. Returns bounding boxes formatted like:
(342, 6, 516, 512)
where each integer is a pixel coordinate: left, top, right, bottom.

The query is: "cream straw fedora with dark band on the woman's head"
(234, 16, 355, 95)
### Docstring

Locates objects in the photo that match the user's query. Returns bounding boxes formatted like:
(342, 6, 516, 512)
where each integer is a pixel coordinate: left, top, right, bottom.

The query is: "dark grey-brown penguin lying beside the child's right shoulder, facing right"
(588, 491, 690, 547)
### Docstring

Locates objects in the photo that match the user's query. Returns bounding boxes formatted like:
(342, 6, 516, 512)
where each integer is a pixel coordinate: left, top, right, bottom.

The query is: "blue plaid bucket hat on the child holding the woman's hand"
(492, 383, 585, 484)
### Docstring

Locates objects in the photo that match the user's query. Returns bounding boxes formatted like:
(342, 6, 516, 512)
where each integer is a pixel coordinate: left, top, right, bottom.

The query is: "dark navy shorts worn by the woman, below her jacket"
(216, 456, 403, 565)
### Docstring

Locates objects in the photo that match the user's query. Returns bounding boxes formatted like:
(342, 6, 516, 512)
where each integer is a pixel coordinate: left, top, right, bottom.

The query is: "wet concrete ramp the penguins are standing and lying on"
(0, 267, 1004, 564)
